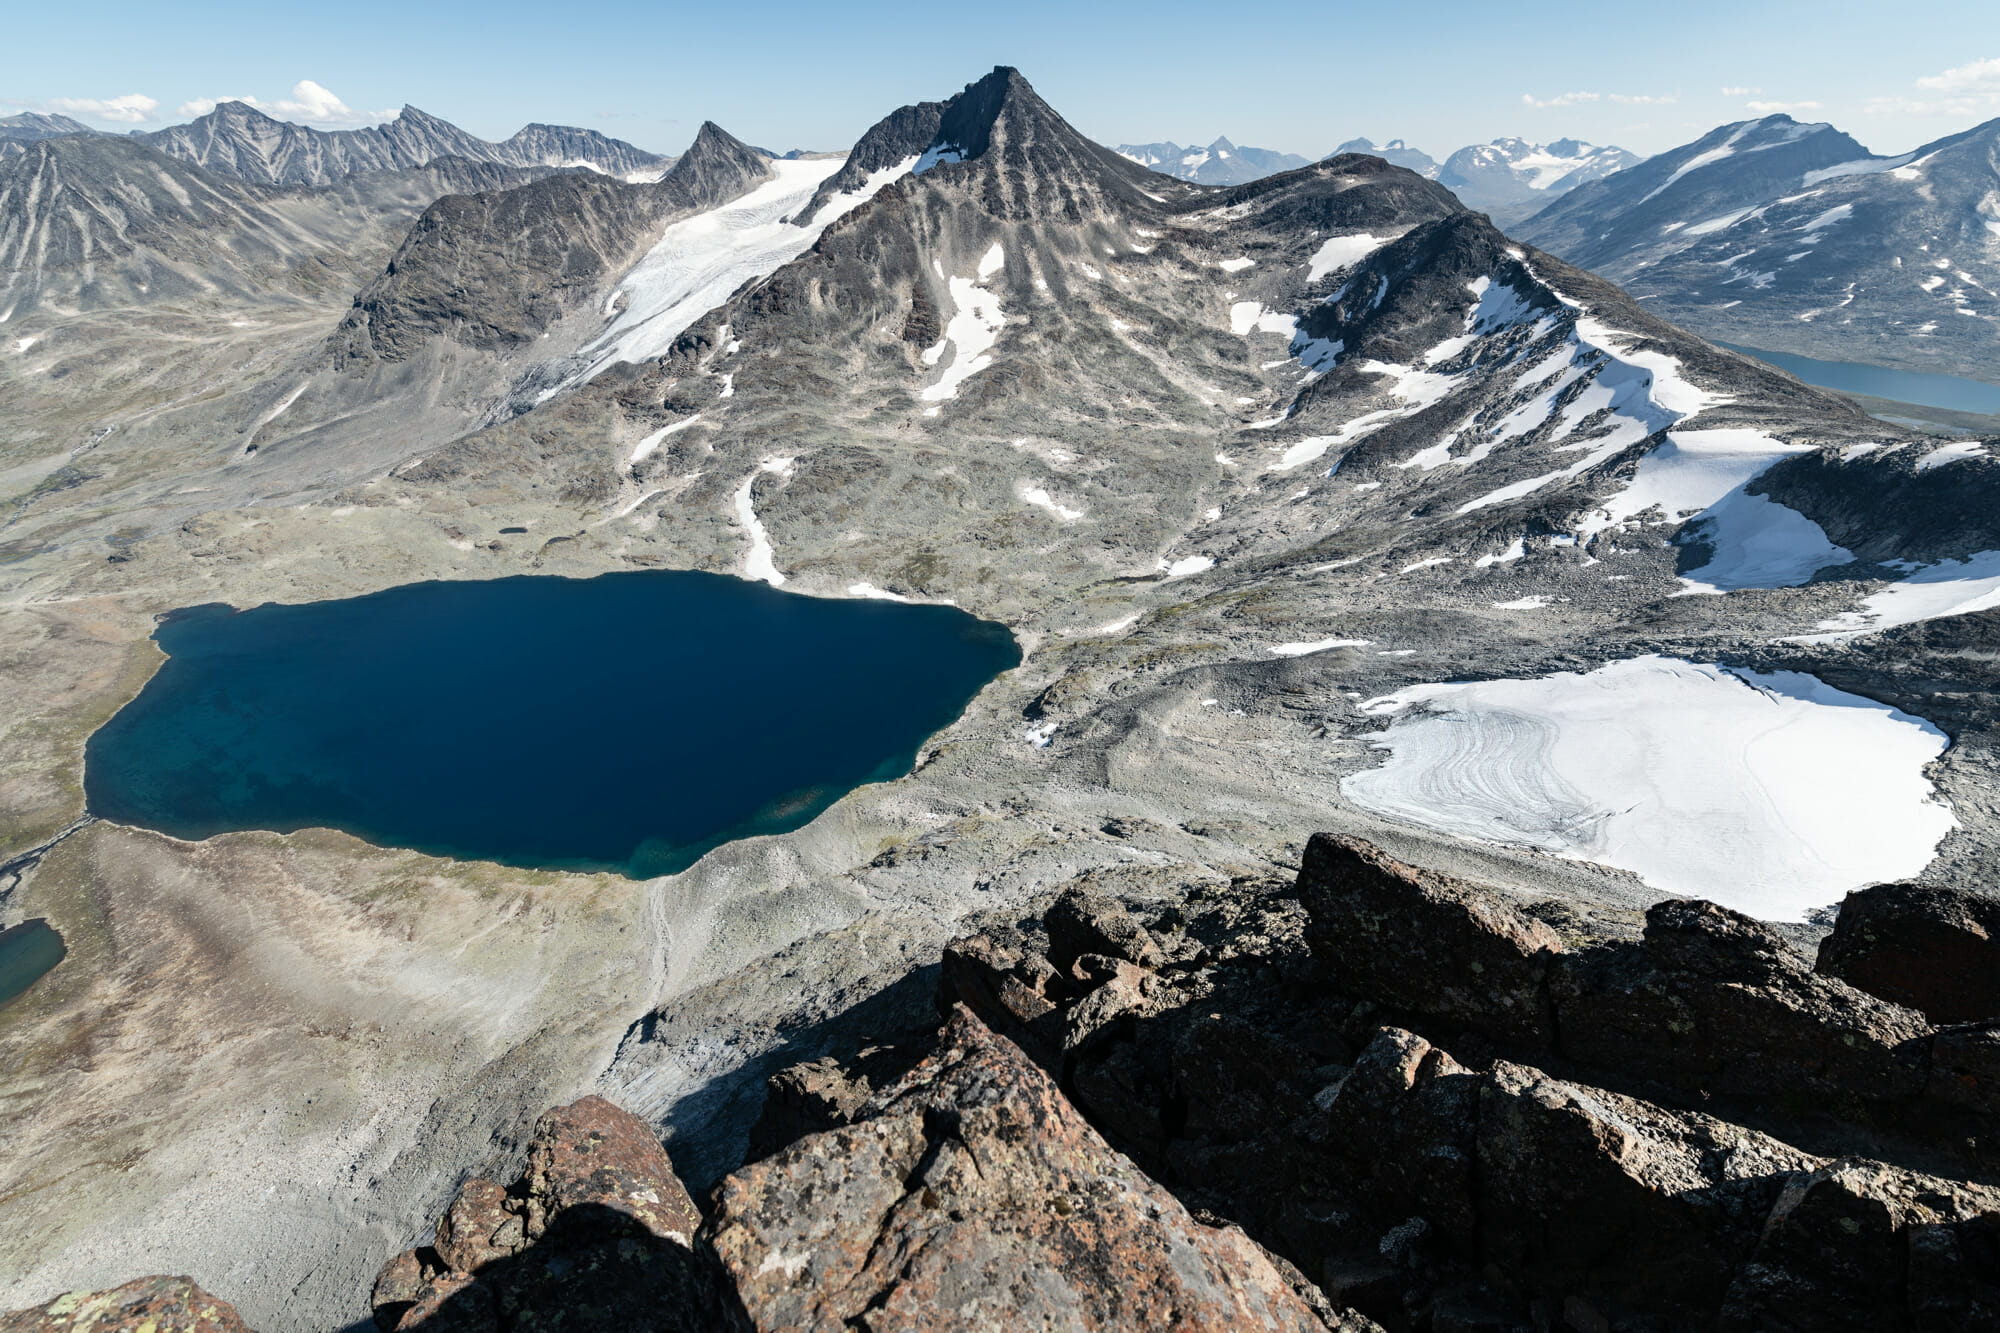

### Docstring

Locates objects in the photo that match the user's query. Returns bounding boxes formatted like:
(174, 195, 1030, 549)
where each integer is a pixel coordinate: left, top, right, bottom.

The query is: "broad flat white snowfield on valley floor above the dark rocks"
(1340, 656, 1956, 921)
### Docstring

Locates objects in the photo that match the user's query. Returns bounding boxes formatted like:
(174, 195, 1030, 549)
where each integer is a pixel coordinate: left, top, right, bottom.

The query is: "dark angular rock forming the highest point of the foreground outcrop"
(1298, 833, 1562, 1043)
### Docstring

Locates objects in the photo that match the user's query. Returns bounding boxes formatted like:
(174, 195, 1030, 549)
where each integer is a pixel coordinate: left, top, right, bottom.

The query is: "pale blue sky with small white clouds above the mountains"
(0, 0, 2000, 158)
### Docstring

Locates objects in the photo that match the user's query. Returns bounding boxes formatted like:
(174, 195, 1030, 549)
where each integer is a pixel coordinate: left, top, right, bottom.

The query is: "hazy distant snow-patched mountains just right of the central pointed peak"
(1118, 138, 1642, 226)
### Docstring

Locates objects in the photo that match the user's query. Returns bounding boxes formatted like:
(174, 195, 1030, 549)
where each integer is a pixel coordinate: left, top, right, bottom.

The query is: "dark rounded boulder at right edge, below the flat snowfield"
(1818, 885, 2000, 1023)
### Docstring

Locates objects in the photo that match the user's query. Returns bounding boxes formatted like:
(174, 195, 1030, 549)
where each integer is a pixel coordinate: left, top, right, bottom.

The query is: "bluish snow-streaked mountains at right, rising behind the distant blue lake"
(1516, 116, 2000, 380)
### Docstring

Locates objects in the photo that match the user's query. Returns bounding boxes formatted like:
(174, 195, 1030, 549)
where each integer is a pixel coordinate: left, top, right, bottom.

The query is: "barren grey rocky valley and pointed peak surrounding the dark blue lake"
(0, 68, 2000, 1329)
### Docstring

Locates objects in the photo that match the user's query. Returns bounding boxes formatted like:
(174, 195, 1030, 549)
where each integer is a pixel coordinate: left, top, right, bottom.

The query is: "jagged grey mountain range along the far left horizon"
(0, 102, 674, 186)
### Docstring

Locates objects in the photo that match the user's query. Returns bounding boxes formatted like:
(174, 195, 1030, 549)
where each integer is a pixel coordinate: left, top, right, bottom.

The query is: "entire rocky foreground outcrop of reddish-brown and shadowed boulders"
(15, 835, 2000, 1333)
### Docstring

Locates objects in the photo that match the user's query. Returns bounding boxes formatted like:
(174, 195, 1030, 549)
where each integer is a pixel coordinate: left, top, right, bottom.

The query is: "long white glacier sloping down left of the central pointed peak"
(560, 158, 916, 398)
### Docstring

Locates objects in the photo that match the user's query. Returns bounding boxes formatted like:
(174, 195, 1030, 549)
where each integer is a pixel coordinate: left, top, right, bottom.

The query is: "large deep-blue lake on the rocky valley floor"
(84, 570, 1020, 879)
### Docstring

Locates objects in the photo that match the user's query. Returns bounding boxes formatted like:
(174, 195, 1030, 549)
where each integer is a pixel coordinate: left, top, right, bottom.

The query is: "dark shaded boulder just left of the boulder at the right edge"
(1550, 901, 1930, 1105)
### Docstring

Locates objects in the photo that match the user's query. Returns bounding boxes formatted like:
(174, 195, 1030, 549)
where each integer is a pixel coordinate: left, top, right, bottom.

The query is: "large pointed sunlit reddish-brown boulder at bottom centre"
(708, 1007, 1324, 1333)
